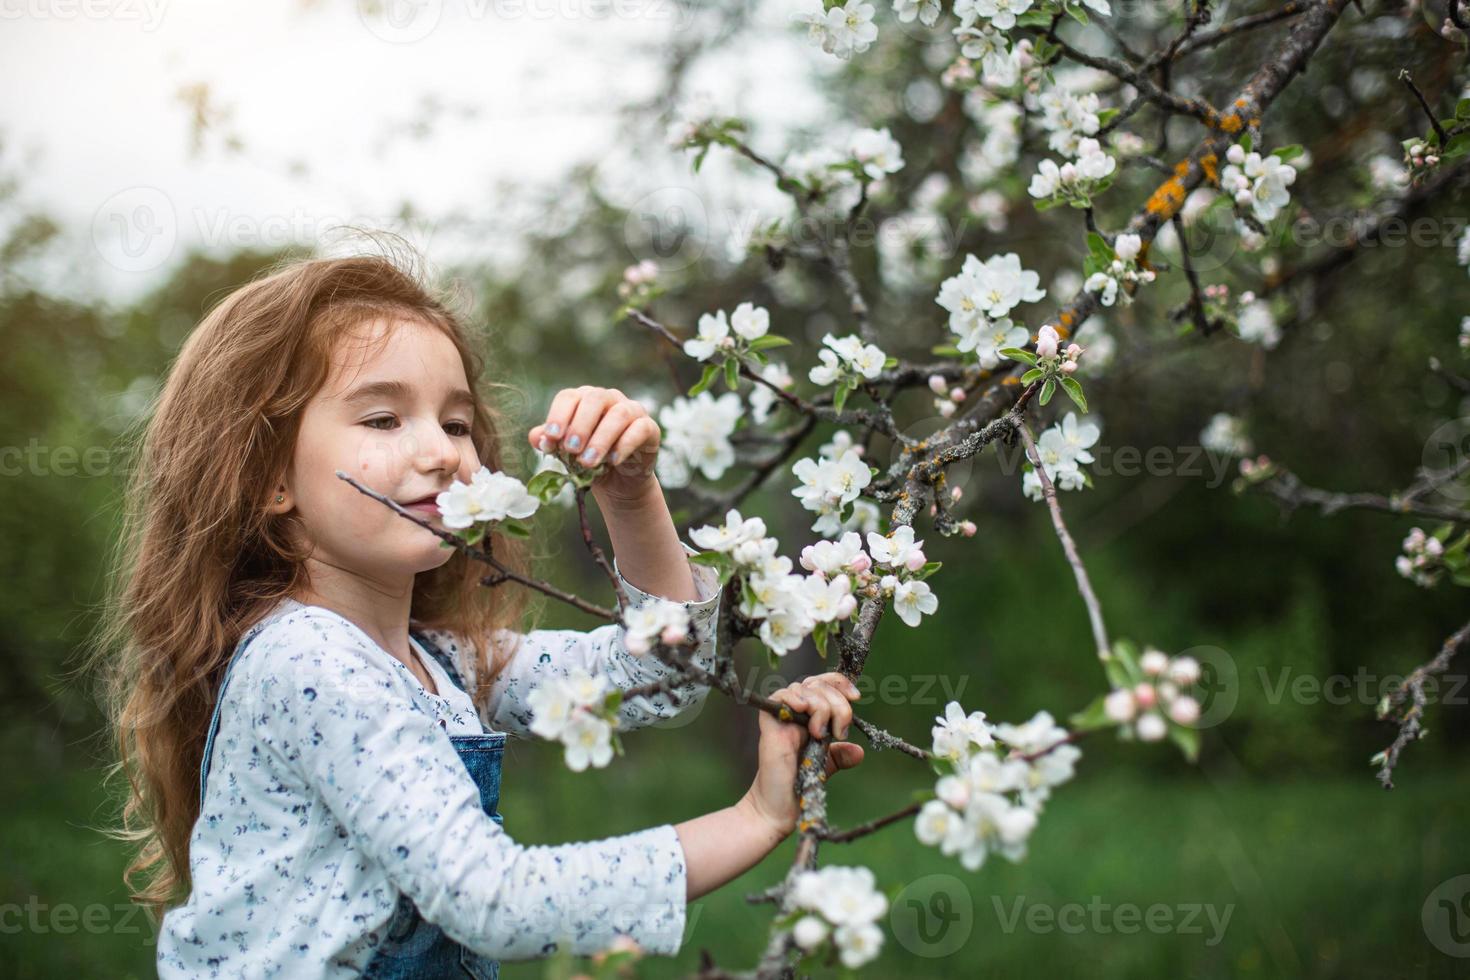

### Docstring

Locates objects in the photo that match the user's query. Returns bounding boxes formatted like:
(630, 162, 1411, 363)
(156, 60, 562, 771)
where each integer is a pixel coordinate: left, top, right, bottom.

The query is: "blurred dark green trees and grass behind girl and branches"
(0, 1, 1470, 980)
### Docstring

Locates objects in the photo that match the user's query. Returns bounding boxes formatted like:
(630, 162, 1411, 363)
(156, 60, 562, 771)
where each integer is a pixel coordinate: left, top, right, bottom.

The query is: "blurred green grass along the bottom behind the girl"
(11, 725, 1470, 980)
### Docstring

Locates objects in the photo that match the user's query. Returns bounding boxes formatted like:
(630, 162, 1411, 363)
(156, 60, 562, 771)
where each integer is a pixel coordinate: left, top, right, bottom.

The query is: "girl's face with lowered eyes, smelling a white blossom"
(282, 319, 479, 586)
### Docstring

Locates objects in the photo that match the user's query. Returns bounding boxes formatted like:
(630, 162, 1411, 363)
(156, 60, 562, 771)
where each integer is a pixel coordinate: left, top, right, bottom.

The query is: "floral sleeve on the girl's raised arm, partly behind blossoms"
(425, 545, 720, 736)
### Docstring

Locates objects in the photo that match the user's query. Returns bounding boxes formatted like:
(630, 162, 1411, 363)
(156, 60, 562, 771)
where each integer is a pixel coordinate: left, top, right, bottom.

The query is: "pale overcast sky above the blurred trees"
(0, 0, 835, 298)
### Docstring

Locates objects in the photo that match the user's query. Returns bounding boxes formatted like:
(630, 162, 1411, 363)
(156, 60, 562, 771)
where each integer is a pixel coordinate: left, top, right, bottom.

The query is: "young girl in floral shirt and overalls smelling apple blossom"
(103, 249, 863, 979)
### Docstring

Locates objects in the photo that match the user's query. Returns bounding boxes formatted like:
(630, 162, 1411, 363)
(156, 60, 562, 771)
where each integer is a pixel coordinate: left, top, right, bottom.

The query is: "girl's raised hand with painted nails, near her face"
(526, 385, 663, 501)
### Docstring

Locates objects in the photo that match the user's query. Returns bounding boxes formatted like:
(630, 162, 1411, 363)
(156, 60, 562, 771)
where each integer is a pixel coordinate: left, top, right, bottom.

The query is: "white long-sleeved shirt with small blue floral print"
(157, 545, 719, 980)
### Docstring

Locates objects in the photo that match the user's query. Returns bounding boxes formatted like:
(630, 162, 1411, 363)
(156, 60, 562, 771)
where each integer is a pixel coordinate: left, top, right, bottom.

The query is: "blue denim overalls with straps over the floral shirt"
(198, 623, 506, 980)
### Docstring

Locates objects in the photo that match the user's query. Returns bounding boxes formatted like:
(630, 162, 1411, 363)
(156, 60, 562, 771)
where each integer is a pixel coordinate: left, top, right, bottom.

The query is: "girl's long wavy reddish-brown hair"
(93, 245, 528, 917)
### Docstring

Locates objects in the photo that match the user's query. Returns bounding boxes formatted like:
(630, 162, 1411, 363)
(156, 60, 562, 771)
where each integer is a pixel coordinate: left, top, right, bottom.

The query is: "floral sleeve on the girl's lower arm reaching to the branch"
(245, 628, 686, 959)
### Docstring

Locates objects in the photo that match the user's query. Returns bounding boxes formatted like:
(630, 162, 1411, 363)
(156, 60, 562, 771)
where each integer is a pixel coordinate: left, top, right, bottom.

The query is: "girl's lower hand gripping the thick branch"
(741, 670, 863, 837)
